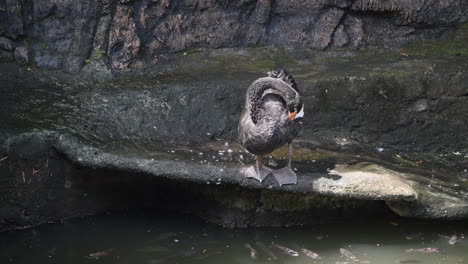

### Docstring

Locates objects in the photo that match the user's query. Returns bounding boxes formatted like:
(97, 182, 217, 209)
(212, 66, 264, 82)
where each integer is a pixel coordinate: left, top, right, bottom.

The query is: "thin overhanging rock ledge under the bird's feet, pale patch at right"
(2, 132, 468, 223)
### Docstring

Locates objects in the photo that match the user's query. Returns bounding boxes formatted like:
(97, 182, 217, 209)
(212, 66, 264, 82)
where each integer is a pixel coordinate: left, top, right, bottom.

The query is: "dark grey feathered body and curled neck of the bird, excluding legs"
(239, 71, 302, 155)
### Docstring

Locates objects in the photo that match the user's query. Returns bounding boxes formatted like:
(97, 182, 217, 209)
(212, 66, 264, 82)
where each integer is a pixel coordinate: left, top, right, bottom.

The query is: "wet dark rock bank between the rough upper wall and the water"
(0, 49, 468, 229)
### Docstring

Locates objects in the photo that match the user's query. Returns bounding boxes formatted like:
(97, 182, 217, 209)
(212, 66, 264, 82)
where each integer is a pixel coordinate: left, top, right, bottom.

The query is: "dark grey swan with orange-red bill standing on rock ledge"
(238, 69, 304, 186)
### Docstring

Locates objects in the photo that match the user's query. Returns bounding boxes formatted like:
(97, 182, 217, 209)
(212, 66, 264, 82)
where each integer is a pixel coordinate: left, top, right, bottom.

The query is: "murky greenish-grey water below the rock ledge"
(0, 214, 468, 264)
